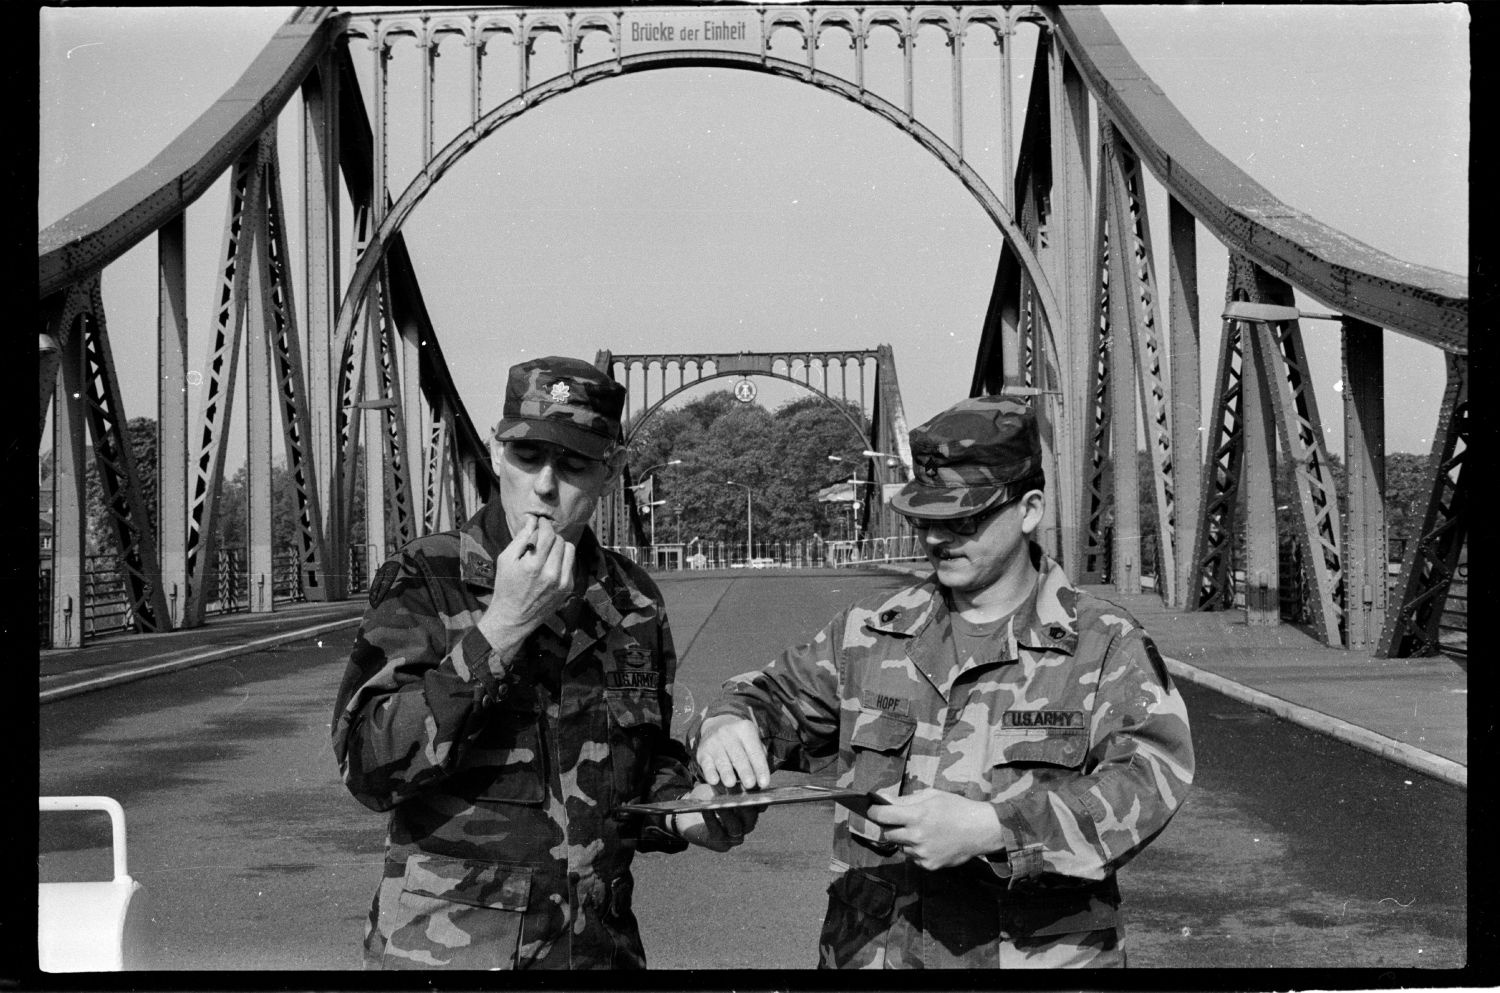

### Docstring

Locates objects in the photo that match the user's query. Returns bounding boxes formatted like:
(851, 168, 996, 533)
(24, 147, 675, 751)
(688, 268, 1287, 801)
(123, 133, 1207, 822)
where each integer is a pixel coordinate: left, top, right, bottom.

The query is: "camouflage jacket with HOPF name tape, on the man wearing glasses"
(708, 546, 1193, 968)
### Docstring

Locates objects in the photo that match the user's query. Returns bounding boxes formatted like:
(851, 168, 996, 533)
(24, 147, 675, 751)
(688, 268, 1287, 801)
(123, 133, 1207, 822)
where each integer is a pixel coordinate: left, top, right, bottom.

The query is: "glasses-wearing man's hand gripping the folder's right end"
(866, 789, 1005, 869)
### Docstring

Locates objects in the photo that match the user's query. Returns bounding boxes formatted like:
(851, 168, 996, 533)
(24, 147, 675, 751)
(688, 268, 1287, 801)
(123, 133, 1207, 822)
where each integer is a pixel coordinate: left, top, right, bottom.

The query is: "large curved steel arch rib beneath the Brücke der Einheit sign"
(333, 48, 1062, 447)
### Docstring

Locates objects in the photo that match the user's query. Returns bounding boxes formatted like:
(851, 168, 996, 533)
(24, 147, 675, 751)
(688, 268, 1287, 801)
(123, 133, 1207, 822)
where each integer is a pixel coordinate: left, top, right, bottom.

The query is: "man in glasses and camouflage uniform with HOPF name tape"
(678, 396, 1193, 969)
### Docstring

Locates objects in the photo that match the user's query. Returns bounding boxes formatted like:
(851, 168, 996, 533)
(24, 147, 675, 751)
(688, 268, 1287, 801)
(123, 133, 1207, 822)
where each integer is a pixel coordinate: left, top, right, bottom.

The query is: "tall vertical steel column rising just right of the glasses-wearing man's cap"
(1043, 33, 1092, 573)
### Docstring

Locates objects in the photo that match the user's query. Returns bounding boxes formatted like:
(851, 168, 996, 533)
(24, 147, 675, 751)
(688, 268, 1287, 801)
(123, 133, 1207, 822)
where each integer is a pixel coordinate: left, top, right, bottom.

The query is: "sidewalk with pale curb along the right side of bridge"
(891, 564, 1469, 789)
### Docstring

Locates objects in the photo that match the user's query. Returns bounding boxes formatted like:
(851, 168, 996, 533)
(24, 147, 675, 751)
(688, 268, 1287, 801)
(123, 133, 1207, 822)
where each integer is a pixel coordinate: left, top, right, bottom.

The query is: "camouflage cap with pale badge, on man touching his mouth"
(495, 356, 626, 459)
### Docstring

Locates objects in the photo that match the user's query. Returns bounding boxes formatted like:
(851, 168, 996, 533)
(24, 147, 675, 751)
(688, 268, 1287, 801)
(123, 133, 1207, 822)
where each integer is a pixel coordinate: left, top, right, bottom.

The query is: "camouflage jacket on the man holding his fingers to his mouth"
(333, 500, 692, 969)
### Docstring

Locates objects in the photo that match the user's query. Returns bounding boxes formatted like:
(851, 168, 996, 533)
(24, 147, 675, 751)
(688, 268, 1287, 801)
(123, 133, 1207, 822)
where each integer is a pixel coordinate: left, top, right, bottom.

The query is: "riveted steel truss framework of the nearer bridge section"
(39, 5, 1469, 654)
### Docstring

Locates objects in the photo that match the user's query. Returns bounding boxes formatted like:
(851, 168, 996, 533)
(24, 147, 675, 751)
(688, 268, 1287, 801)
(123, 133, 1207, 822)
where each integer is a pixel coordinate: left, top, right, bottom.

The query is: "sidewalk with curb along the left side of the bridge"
(38, 597, 366, 704)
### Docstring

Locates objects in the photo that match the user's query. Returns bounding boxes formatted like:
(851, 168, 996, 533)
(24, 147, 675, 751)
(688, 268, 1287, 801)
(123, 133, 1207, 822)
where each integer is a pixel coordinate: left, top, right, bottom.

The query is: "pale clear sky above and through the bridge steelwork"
(38, 3, 1470, 465)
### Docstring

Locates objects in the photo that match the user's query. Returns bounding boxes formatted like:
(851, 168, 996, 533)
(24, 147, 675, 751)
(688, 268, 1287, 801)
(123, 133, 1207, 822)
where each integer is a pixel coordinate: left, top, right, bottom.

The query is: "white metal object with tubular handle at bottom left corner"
(36, 797, 156, 972)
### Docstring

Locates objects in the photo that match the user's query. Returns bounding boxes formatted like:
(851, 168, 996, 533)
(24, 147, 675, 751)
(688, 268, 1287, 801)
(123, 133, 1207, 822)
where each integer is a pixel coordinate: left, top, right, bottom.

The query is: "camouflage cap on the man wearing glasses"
(891, 396, 1043, 521)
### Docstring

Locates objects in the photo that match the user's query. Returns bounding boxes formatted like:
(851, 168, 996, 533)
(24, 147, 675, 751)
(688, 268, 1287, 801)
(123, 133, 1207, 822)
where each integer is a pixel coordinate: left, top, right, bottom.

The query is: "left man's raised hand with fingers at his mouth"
(479, 515, 576, 648)
